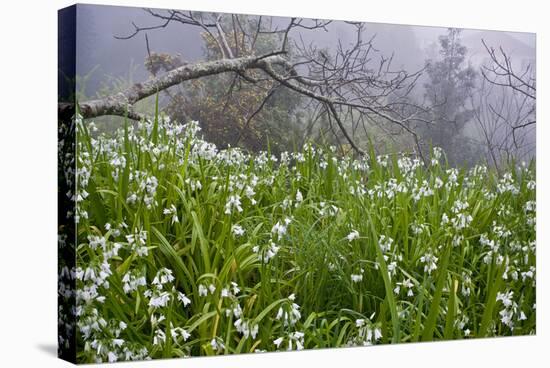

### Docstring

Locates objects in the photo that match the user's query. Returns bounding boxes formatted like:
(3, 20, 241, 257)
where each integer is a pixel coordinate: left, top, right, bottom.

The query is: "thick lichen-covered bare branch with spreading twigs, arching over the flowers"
(75, 9, 436, 158)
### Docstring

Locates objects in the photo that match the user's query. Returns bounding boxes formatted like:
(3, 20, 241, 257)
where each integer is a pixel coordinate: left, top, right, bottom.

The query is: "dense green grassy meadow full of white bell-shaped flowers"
(71, 112, 536, 362)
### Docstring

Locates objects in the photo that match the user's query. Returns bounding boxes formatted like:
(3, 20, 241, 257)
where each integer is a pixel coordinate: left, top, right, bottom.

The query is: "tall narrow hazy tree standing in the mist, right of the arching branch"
(423, 28, 477, 164)
